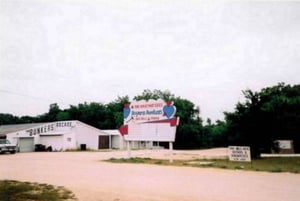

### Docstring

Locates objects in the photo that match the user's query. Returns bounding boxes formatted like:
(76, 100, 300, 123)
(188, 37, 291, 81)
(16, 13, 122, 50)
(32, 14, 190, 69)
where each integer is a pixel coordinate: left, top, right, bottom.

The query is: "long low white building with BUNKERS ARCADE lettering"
(0, 121, 125, 152)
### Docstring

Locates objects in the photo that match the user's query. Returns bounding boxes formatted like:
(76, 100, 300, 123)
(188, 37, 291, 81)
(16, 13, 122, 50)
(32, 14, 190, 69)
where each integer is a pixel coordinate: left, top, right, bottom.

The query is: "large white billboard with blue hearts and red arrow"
(119, 99, 178, 142)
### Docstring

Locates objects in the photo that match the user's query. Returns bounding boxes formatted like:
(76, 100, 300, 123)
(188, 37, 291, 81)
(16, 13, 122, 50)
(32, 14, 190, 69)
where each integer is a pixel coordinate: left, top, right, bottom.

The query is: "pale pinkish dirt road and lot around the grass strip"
(0, 150, 300, 201)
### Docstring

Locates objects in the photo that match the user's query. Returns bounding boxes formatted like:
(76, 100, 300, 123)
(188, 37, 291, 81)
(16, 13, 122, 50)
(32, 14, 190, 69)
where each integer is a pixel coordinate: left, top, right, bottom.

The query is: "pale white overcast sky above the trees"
(0, 0, 300, 120)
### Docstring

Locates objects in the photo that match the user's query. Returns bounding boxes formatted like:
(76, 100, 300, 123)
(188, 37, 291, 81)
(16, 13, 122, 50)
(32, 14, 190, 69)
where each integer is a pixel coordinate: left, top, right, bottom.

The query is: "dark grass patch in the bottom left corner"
(0, 180, 77, 201)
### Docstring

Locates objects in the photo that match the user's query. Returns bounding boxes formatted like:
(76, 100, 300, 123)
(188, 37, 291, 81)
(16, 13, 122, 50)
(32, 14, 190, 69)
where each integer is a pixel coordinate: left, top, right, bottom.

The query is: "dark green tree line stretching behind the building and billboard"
(0, 83, 300, 156)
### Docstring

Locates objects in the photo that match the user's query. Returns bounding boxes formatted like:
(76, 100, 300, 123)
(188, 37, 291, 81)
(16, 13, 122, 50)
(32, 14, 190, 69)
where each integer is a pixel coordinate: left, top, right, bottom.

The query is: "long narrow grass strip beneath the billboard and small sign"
(106, 157, 300, 173)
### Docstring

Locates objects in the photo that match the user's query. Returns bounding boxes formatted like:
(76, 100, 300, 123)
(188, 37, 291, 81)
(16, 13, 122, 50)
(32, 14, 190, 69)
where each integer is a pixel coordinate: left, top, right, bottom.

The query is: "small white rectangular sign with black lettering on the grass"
(228, 146, 251, 162)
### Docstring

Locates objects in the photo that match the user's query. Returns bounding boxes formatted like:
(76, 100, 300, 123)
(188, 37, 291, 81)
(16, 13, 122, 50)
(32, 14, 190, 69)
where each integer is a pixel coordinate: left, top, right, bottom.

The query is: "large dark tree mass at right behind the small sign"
(225, 83, 300, 157)
